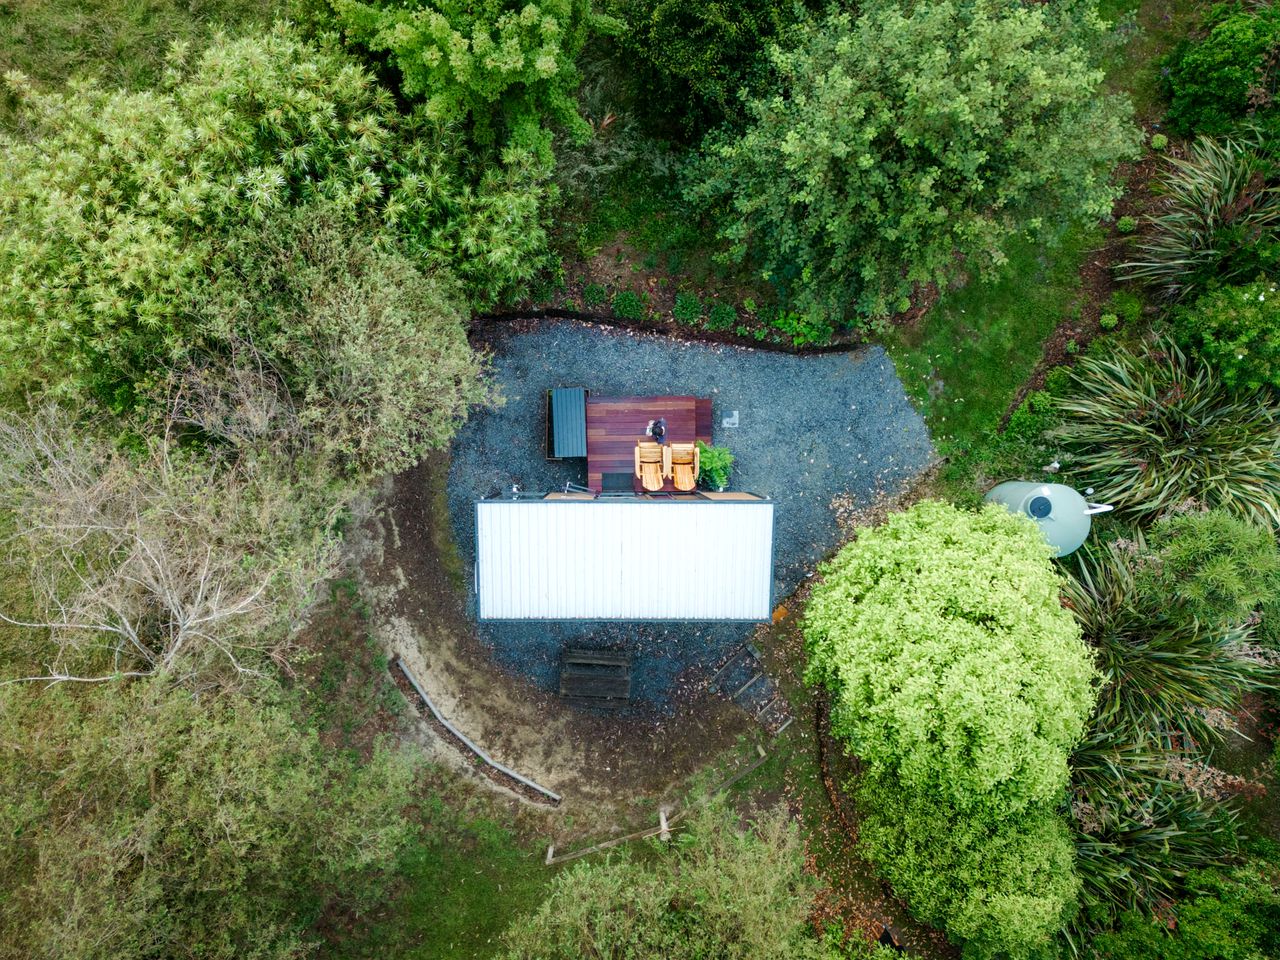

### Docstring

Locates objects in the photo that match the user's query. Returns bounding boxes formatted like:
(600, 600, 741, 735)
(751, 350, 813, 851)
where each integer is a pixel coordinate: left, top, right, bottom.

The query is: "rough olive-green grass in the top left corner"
(0, 0, 287, 127)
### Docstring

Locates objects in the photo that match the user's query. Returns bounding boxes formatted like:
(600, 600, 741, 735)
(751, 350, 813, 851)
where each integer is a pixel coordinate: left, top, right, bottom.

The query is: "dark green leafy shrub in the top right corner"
(1162, 4, 1280, 137)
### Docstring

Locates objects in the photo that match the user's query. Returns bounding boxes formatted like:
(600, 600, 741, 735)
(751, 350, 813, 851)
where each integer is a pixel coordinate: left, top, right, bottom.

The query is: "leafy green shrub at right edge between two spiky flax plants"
(1175, 280, 1280, 390)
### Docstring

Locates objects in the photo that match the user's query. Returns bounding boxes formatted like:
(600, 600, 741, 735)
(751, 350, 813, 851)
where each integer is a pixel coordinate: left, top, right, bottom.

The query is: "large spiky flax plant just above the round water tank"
(1051, 340, 1280, 526)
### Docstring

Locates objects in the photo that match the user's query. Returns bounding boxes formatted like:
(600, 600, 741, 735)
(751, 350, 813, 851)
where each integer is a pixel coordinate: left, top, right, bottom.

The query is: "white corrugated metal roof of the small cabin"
(476, 500, 773, 621)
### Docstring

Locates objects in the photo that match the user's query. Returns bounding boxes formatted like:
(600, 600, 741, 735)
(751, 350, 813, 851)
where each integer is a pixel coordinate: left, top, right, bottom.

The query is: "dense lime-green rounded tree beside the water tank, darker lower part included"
(804, 500, 1094, 957)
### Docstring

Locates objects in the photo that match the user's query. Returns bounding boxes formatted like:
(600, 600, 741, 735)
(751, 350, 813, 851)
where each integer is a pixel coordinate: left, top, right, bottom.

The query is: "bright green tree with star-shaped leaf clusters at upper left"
(0, 27, 545, 411)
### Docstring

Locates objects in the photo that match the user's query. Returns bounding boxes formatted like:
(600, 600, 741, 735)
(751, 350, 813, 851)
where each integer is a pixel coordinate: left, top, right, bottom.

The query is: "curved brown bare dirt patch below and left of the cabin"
(360, 456, 759, 844)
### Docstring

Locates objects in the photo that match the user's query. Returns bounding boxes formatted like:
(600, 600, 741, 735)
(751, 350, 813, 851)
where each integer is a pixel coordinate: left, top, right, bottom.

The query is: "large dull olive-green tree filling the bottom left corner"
(0, 678, 413, 960)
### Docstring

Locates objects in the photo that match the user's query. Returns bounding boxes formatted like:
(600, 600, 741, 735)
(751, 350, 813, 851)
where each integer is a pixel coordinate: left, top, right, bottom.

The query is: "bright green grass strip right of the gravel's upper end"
(884, 228, 1101, 454)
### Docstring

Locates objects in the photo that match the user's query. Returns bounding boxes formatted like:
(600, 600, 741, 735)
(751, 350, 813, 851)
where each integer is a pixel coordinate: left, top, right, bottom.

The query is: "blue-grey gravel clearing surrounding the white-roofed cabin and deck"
(448, 321, 934, 713)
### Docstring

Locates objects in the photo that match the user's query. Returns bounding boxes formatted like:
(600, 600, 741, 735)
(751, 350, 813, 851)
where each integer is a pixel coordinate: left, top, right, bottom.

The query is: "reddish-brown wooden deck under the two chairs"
(586, 397, 712, 493)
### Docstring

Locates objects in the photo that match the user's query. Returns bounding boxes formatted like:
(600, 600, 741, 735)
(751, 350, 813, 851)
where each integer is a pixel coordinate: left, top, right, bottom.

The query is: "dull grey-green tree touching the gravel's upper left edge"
(192, 205, 495, 476)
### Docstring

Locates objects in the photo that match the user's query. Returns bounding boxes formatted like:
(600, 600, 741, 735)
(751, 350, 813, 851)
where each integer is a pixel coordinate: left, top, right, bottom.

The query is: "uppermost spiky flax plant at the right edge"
(1117, 134, 1280, 301)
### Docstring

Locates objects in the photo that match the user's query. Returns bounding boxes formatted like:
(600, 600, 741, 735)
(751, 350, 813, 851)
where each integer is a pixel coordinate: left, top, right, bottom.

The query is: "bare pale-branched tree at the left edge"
(0, 407, 335, 682)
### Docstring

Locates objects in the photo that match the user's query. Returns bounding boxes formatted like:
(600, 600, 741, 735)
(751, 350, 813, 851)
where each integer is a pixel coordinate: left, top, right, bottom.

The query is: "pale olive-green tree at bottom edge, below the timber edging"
(506, 800, 817, 960)
